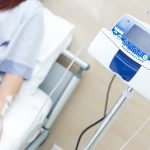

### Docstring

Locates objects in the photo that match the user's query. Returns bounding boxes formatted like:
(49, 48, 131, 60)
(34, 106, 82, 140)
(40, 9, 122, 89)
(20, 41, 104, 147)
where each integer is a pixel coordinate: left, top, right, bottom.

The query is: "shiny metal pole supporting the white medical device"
(84, 87, 133, 150)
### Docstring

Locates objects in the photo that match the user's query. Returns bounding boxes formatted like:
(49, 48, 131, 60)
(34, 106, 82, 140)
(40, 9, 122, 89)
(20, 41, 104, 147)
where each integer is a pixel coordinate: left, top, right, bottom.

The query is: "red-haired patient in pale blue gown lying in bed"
(0, 0, 44, 139)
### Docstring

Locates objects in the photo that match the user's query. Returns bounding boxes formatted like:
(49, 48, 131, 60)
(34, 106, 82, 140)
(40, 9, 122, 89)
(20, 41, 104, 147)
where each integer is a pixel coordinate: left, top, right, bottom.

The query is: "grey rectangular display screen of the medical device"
(125, 25, 150, 55)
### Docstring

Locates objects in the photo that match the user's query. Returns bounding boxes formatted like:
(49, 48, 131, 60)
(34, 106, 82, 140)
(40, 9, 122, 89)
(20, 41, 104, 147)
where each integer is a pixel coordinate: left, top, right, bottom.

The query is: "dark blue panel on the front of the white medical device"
(109, 50, 141, 81)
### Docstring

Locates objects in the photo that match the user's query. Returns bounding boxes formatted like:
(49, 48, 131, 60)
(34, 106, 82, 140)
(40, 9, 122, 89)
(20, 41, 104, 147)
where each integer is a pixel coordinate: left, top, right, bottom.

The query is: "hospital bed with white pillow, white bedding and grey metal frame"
(0, 9, 89, 150)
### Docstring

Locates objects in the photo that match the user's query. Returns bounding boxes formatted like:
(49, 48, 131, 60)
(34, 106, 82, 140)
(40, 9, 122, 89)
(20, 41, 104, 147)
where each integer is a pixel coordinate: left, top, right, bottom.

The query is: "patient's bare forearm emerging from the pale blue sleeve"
(0, 73, 23, 113)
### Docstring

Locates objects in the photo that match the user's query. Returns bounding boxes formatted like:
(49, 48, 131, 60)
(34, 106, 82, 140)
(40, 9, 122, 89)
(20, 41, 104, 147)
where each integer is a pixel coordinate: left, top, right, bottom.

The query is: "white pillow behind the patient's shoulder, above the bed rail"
(23, 8, 74, 88)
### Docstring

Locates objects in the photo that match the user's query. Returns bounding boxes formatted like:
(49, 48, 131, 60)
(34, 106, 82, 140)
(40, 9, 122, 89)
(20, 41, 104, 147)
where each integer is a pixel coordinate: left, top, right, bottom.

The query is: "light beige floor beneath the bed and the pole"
(39, 0, 150, 150)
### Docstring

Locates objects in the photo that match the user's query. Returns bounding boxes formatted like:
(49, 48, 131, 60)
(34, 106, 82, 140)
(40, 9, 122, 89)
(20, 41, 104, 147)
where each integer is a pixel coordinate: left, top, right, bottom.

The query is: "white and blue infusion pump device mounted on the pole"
(88, 15, 150, 99)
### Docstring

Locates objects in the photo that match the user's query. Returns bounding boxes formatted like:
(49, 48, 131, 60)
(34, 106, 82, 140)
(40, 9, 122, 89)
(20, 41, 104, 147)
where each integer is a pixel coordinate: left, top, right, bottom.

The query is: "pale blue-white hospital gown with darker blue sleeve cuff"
(0, 0, 44, 81)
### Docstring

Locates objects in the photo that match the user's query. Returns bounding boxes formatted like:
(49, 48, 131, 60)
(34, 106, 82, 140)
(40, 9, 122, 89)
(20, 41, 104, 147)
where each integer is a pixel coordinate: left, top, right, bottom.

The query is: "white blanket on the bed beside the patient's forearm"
(0, 89, 52, 150)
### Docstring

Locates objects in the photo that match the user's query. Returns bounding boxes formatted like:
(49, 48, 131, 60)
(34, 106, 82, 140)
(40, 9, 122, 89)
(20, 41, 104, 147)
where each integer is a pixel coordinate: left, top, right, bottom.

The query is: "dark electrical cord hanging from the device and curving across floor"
(75, 75, 116, 150)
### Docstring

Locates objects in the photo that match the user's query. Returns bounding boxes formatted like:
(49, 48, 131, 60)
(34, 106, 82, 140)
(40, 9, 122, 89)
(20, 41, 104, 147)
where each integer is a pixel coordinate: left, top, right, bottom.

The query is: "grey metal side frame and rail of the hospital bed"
(26, 50, 90, 150)
